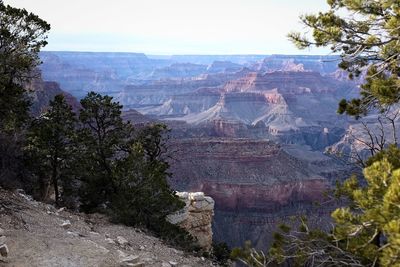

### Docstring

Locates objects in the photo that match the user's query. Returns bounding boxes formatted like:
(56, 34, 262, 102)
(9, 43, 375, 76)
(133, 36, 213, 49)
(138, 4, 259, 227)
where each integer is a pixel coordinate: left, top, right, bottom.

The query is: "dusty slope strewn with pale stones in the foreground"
(0, 188, 217, 267)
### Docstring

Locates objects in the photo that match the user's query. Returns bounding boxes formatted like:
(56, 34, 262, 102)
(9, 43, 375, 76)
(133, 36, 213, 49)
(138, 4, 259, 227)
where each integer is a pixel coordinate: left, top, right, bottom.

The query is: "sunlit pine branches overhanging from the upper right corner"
(289, 0, 400, 118)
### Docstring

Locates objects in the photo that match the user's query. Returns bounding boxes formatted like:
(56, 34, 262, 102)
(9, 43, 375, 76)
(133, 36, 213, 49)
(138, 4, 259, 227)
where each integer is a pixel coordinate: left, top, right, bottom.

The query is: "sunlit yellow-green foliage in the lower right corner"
(332, 158, 400, 266)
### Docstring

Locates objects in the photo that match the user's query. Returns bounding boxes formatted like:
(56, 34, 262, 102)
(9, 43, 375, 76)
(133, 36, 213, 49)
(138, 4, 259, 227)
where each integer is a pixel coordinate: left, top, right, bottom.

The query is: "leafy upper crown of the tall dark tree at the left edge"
(0, 2, 50, 131)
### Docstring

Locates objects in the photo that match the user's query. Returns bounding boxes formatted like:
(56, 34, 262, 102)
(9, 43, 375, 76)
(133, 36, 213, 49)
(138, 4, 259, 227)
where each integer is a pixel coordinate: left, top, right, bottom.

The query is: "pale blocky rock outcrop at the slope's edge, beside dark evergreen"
(167, 192, 214, 251)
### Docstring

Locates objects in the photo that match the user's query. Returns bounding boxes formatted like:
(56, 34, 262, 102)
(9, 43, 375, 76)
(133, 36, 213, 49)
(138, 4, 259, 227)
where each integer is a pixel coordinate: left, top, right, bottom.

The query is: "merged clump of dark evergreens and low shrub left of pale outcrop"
(77, 92, 191, 249)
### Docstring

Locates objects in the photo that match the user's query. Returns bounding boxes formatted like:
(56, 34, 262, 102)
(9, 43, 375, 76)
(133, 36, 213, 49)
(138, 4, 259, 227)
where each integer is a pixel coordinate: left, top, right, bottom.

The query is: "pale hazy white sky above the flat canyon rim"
(4, 0, 328, 54)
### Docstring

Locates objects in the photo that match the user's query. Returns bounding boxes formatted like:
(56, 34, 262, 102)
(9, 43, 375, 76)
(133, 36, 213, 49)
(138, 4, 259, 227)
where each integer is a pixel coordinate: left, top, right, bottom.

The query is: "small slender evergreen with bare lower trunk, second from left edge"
(26, 95, 76, 205)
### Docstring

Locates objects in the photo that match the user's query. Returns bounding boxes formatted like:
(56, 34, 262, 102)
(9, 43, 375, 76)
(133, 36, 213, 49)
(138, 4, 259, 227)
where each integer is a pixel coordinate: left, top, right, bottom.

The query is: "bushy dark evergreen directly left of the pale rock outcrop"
(113, 124, 184, 227)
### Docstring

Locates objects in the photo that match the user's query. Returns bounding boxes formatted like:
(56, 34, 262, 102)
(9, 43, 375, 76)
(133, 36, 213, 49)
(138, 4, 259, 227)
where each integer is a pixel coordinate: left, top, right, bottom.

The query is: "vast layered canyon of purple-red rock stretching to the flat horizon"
(41, 52, 366, 251)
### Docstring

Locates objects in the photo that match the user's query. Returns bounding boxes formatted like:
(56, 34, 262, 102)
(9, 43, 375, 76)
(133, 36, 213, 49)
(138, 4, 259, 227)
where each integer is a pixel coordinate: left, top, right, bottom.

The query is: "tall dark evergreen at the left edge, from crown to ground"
(0, 0, 50, 191)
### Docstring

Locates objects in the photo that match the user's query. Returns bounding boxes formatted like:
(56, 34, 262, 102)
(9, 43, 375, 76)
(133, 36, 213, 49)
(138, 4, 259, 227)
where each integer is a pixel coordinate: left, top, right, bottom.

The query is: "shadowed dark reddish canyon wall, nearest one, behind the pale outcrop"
(170, 138, 345, 248)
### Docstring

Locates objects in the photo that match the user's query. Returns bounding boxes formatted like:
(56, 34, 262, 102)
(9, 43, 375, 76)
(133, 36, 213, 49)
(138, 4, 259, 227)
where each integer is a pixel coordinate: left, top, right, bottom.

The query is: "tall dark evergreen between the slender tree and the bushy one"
(79, 92, 132, 214)
